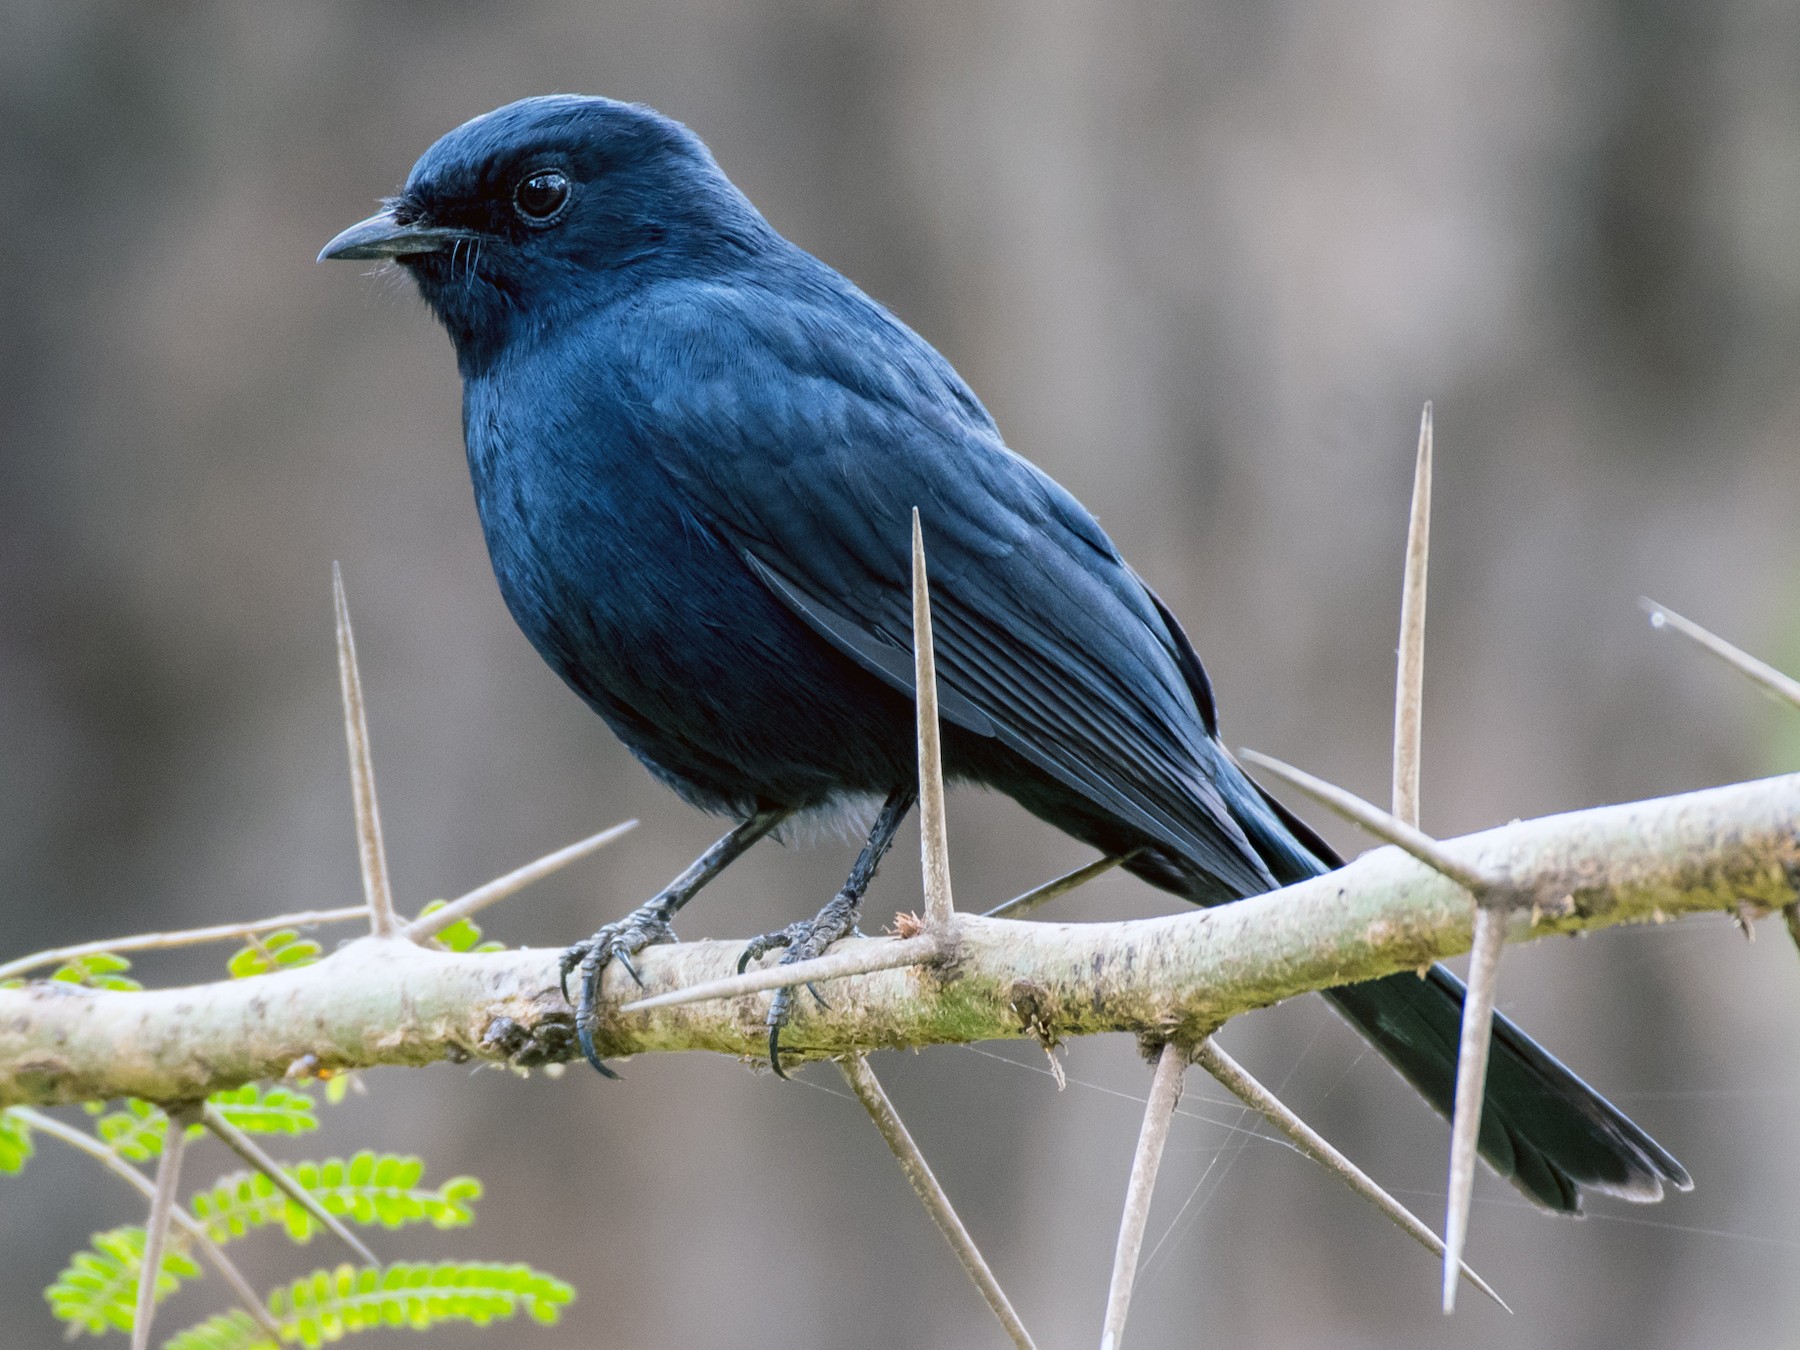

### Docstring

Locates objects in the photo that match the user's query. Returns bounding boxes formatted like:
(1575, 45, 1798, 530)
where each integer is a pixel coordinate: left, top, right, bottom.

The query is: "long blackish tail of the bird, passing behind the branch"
(1125, 781, 1694, 1213)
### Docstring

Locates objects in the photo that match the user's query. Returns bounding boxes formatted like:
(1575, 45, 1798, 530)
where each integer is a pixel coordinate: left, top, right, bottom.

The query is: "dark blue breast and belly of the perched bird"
(464, 370, 911, 810)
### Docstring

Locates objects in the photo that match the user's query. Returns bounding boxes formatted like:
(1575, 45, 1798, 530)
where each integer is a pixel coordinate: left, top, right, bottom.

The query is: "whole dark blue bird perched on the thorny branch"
(319, 95, 1692, 1213)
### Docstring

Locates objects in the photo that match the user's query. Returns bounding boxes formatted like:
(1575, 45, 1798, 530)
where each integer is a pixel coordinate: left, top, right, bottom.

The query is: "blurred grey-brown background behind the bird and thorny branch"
(0, 0, 1800, 1350)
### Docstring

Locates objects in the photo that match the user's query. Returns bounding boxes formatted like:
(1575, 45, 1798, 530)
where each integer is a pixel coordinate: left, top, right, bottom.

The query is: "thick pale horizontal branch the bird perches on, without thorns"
(0, 774, 1800, 1105)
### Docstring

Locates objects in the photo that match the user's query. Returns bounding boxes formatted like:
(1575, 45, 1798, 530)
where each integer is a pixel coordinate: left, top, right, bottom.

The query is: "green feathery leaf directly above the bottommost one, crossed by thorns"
(193, 1150, 481, 1242)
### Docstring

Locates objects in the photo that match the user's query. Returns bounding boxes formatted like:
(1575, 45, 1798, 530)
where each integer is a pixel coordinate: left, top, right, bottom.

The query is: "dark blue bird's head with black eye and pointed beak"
(319, 95, 774, 371)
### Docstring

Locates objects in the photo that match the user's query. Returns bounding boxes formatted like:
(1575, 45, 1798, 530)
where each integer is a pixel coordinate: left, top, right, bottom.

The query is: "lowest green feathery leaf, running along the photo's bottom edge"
(164, 1262, 574, 1350)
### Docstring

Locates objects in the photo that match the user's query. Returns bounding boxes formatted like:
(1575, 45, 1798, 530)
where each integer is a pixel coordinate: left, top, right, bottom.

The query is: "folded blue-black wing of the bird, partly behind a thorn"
(607, 283, 1273, 895)
